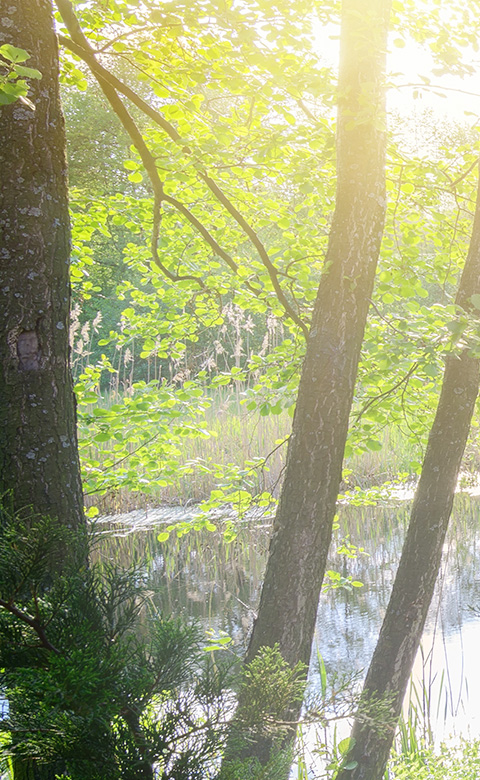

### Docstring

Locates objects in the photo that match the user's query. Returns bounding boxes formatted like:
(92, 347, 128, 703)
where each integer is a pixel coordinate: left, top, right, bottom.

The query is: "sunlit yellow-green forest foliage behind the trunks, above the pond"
(64, 1, 478, 511)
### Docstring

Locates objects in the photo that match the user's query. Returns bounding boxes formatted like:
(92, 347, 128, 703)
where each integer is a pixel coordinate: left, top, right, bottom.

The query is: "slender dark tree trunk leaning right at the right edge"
(337, 168, 480, 780)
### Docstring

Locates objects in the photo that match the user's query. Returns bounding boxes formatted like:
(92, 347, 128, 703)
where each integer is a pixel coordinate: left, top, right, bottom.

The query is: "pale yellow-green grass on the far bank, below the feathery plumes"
(83, 388, 428, 513)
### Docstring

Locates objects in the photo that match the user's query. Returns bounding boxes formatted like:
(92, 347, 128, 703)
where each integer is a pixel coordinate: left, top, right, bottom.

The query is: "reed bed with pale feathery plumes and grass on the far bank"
(70, 302, 438, 513)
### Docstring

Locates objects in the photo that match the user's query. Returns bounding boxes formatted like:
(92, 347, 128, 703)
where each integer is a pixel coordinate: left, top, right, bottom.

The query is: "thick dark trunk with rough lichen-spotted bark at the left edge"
(0, 0, 83, 526)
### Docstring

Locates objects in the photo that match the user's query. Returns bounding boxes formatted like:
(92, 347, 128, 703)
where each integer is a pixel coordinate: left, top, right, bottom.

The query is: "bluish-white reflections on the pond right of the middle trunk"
(317, 496, 480, 672)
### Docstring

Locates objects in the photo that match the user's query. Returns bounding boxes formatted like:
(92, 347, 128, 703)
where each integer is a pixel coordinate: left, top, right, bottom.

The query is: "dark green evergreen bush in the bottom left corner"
(0, 510, 231, 780)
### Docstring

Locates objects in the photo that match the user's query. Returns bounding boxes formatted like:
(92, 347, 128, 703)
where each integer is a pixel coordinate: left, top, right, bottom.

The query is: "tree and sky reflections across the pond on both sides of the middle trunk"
(93, 495, 480, 673)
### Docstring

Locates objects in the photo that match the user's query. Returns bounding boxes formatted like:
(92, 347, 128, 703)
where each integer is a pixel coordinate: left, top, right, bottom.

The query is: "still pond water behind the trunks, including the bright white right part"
(94, 494, 480, 768)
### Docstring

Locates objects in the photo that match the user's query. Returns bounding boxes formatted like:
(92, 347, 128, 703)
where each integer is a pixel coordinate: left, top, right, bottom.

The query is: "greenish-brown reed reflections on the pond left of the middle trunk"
(97, 524, 268, 652)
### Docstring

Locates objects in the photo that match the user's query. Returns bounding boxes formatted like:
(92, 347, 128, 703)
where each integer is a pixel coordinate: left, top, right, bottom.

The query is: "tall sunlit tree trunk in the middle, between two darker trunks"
(221, 0, 390, 763)
